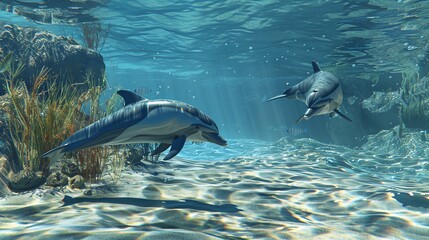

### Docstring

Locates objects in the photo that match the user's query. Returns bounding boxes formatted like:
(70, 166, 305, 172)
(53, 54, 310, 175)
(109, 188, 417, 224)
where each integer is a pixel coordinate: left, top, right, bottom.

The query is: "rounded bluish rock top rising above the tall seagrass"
(0, 24, 105, 94)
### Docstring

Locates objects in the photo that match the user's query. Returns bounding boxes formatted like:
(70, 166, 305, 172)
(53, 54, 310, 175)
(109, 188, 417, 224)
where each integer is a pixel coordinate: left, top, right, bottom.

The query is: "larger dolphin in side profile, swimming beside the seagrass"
(41, 90, 227, 162)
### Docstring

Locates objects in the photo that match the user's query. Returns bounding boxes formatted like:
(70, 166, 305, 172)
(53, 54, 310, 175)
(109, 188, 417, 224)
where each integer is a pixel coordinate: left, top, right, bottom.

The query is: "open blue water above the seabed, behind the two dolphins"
(4, 0, 427, 142)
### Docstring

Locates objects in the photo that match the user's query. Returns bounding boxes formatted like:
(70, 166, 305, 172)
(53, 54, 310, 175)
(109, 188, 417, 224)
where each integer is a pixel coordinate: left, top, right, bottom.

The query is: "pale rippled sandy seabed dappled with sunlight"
(0, 139, 429, 239)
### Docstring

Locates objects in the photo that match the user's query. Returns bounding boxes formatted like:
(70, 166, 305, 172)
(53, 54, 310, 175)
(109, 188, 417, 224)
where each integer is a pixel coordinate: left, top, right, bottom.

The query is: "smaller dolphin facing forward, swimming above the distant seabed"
(267, 61, 352, 123)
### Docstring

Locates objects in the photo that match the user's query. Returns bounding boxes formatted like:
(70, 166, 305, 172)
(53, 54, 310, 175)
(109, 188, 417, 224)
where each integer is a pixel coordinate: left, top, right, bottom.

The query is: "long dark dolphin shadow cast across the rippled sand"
(63, 195, 242, 213)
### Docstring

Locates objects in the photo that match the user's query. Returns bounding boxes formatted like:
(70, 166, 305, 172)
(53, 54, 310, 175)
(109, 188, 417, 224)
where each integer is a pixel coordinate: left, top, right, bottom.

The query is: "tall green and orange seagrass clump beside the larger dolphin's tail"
(2, 60, 113, 184)
